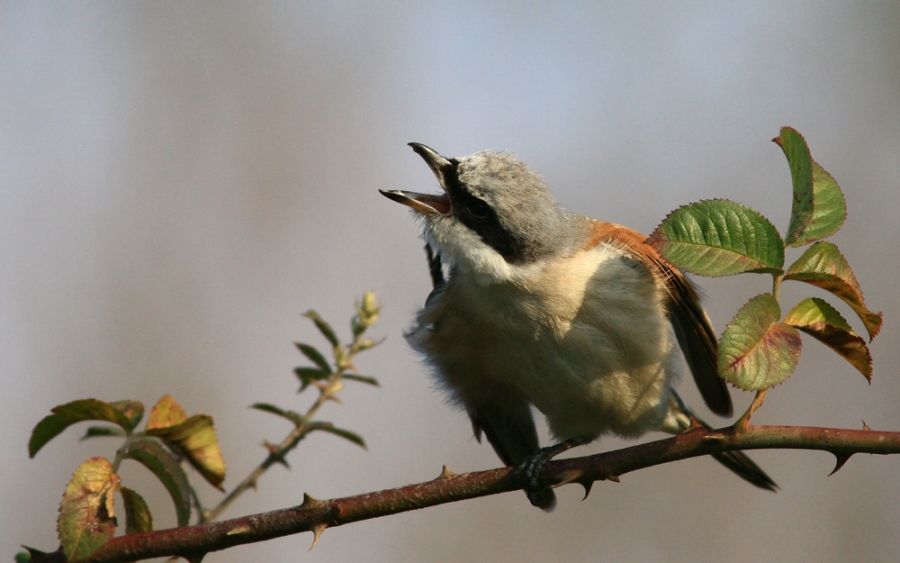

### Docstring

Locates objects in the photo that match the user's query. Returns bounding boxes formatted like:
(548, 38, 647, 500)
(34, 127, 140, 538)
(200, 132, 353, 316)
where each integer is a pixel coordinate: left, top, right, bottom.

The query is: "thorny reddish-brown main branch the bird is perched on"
(75, 426, 900, 563)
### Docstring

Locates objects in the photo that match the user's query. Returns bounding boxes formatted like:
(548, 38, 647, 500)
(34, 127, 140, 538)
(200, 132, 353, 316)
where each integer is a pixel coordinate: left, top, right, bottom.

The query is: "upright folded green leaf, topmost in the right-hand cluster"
(773, 127, 847, 246)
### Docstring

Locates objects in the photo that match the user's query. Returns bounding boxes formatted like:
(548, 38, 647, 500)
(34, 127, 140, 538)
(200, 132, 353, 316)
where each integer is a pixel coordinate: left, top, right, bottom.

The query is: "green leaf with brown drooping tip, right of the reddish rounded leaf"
(784, 297, 872, 381)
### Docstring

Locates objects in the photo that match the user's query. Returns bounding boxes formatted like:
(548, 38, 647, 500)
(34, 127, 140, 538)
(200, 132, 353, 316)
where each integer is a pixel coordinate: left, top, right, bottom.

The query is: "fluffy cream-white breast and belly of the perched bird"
(410, 245, 672, 439)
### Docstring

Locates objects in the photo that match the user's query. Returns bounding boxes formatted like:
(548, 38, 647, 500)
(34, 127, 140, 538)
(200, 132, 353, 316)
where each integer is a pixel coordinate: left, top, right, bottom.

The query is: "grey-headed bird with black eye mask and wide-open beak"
(379, 143, 777, 511)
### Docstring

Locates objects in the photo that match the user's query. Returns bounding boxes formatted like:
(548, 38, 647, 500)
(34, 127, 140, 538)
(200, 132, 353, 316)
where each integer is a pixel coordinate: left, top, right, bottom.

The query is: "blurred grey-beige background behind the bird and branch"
(0, 1, 900, 562)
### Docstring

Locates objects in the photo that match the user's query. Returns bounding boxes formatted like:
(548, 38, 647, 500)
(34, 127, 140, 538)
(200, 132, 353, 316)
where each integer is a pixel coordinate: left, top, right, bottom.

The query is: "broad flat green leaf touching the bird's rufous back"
(647, 199, 784, 277)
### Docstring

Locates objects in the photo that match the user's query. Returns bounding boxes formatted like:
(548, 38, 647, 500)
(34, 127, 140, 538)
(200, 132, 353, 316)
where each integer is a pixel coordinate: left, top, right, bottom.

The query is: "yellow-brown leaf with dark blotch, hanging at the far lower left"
(57, 457, 119, 561)
